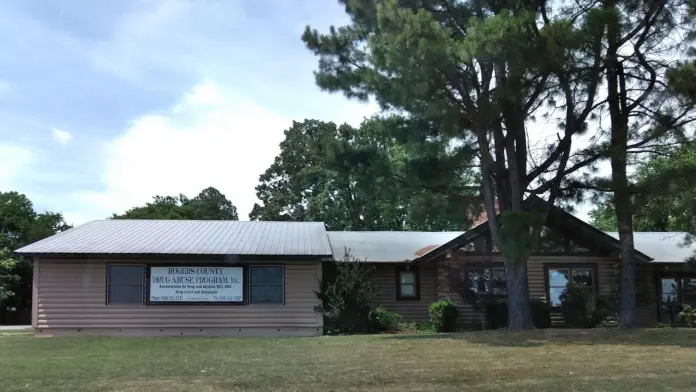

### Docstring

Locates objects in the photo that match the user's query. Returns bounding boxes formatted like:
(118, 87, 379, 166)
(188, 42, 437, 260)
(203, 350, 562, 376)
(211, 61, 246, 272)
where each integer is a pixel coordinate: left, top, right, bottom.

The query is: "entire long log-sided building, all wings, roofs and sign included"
(17, 208, 696, 336)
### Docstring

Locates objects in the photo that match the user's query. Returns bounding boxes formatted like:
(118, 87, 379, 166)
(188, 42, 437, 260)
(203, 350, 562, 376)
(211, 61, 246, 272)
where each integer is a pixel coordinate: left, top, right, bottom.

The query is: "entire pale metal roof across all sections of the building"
(17, 219, 696, 263)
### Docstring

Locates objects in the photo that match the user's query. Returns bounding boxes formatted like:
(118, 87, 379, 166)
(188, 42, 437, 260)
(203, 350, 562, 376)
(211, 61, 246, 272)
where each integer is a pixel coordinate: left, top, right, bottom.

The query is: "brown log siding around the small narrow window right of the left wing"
(372, 264, 437, 322)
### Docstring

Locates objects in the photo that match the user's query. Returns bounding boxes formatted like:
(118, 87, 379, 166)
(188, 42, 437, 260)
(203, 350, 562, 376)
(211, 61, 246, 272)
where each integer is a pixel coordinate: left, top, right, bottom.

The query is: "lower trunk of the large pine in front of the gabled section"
(505, 260, 534, 332)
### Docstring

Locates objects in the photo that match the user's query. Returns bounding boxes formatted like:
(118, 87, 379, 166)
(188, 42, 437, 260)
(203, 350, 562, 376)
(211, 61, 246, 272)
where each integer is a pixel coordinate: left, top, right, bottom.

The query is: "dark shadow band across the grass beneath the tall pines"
(389, 328, 696, 348)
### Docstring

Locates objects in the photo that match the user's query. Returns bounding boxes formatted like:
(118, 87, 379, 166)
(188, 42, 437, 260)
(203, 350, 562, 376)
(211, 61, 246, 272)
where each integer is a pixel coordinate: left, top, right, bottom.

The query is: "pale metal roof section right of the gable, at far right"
(606, 231, 696, 263)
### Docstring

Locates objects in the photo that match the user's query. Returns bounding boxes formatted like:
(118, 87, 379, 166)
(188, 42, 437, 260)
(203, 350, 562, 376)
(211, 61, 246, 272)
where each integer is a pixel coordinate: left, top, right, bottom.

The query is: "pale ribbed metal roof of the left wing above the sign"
(17, 219, 331, 256)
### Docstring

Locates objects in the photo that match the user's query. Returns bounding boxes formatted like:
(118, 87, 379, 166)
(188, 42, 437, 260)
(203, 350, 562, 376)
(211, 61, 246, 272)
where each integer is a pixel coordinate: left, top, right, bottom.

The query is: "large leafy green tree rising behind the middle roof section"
(249, 117, 477, 230)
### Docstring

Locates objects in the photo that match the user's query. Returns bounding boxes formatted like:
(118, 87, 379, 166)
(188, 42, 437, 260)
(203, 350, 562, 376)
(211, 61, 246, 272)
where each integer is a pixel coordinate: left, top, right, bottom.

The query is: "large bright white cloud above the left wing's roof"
(74, 80, 375, 223)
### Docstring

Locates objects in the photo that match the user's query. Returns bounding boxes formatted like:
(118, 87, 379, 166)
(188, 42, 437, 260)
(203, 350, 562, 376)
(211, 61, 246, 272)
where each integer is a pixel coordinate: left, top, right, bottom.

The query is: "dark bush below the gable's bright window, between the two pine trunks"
(560, 285, 615, 328)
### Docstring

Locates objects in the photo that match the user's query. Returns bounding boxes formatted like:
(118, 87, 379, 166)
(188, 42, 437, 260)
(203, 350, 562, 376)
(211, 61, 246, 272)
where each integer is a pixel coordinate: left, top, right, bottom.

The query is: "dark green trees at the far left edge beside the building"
(0, 192, 70, 323)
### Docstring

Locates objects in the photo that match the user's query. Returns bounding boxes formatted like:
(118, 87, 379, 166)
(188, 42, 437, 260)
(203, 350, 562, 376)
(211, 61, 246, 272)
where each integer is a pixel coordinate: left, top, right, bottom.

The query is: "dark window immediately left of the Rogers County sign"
(106, 264, 145, 305)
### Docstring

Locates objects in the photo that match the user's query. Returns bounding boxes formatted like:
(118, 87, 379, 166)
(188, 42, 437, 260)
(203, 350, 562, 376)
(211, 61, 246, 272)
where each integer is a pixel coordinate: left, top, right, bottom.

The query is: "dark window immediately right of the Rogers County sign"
(249, 265, 285, 305)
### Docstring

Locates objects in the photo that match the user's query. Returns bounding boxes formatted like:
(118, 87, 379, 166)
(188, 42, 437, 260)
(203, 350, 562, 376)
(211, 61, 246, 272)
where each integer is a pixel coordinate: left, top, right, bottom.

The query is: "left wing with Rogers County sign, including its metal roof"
(17, 220, 332, 336)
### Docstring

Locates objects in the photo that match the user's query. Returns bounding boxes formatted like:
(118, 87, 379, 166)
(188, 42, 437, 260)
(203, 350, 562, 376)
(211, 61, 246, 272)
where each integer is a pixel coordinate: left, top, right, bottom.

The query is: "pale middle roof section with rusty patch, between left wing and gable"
(328, 231, 463, 262)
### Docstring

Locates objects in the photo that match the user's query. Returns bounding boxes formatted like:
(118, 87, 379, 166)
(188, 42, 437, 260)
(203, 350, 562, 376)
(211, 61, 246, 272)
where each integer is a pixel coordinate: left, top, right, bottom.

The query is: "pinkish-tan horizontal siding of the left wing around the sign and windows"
(34, 259, 322, 330)
